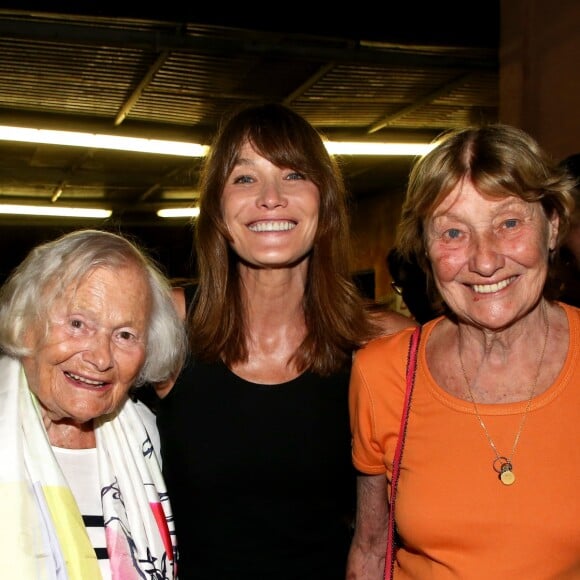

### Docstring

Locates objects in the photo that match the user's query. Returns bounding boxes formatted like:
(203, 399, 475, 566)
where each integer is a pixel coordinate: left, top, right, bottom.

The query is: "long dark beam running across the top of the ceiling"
(0, 14, 498, 70)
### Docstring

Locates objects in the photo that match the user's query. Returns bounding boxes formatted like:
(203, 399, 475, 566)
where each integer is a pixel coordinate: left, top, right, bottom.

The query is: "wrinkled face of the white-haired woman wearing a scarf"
(23, 266, 151, 424)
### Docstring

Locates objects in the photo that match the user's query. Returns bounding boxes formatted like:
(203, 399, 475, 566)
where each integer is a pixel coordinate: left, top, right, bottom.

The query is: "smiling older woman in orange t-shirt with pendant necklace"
(347, 124, 580, 580)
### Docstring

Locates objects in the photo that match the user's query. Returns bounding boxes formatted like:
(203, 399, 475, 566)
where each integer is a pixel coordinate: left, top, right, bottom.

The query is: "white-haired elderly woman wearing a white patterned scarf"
(0, 230, 187, 580)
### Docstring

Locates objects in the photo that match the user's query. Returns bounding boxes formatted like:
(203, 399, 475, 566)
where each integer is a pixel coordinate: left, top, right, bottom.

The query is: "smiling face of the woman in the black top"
(222, 143, 320, 268)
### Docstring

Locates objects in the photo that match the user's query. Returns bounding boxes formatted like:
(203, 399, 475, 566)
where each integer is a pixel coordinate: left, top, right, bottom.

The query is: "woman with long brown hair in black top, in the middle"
(150, 104, 413, 580)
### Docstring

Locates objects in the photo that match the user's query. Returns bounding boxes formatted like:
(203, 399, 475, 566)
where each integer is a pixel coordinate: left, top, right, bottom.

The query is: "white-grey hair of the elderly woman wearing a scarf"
(0, 229, 187, 386)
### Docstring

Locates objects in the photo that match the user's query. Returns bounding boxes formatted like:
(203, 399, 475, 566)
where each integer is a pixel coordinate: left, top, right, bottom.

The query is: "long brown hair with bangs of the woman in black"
(189, 104, 374, 375)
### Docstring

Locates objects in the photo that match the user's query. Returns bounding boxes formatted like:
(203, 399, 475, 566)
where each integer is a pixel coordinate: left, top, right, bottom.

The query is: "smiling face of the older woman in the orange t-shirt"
(426, 180, 558, 329)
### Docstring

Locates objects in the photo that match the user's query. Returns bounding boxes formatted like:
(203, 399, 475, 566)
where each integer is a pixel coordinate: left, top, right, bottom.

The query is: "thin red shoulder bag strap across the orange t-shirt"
(385, 326, 421, 580)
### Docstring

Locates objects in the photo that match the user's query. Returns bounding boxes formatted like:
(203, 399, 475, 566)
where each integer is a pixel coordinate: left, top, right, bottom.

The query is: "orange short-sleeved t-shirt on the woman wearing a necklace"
(350, 304, 580, 580)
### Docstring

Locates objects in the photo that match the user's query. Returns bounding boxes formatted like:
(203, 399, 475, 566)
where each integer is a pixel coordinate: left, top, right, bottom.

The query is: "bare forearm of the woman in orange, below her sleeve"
(346, 475, 389, 580)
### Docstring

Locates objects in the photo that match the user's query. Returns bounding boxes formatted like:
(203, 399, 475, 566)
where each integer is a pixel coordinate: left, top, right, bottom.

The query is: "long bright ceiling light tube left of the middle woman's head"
(0, 125, 208, 157)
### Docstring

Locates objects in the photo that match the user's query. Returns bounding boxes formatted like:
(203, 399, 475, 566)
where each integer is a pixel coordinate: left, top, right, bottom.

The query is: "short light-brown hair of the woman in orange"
(396, 123, 574, 277)
